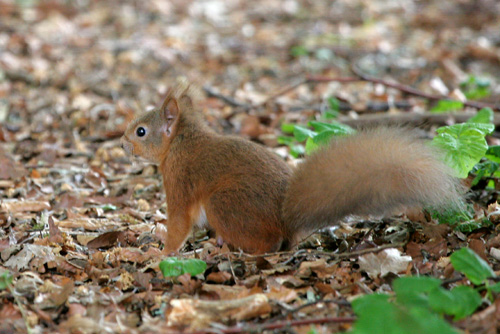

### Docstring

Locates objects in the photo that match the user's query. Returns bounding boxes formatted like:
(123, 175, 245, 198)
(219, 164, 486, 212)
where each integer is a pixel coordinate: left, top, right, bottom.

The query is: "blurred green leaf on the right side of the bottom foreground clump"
(429, 285, 481, 320)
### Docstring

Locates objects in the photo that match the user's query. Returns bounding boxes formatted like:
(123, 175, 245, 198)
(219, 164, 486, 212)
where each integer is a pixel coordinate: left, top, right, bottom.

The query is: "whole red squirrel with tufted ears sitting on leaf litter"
(122, 84, 460, 254)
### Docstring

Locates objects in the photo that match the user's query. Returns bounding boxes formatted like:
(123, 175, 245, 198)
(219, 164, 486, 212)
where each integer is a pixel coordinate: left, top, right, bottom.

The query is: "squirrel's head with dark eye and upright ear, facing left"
(121, 95, 181, 164)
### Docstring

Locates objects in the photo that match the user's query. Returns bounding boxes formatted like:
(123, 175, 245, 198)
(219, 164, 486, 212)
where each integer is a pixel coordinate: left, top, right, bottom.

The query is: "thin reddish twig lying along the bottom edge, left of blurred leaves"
(189, 317, 356, 334)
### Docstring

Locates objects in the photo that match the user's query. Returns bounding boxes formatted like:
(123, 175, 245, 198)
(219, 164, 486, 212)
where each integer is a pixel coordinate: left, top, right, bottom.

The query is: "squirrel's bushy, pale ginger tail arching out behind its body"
(283, 128, 461, 241)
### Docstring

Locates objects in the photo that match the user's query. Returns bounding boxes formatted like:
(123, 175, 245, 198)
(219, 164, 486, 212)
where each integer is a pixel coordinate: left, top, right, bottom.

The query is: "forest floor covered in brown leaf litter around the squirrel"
(0, 0, 500, 333)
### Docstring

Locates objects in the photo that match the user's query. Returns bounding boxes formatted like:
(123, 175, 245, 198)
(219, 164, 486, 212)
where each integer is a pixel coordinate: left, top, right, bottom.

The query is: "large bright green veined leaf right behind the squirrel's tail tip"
(432, 123, 495, 178)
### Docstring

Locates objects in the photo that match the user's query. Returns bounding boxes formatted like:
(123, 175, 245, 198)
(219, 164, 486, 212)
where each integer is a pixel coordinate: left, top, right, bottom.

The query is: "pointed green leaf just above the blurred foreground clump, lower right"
(450, 248, 495, 285)
